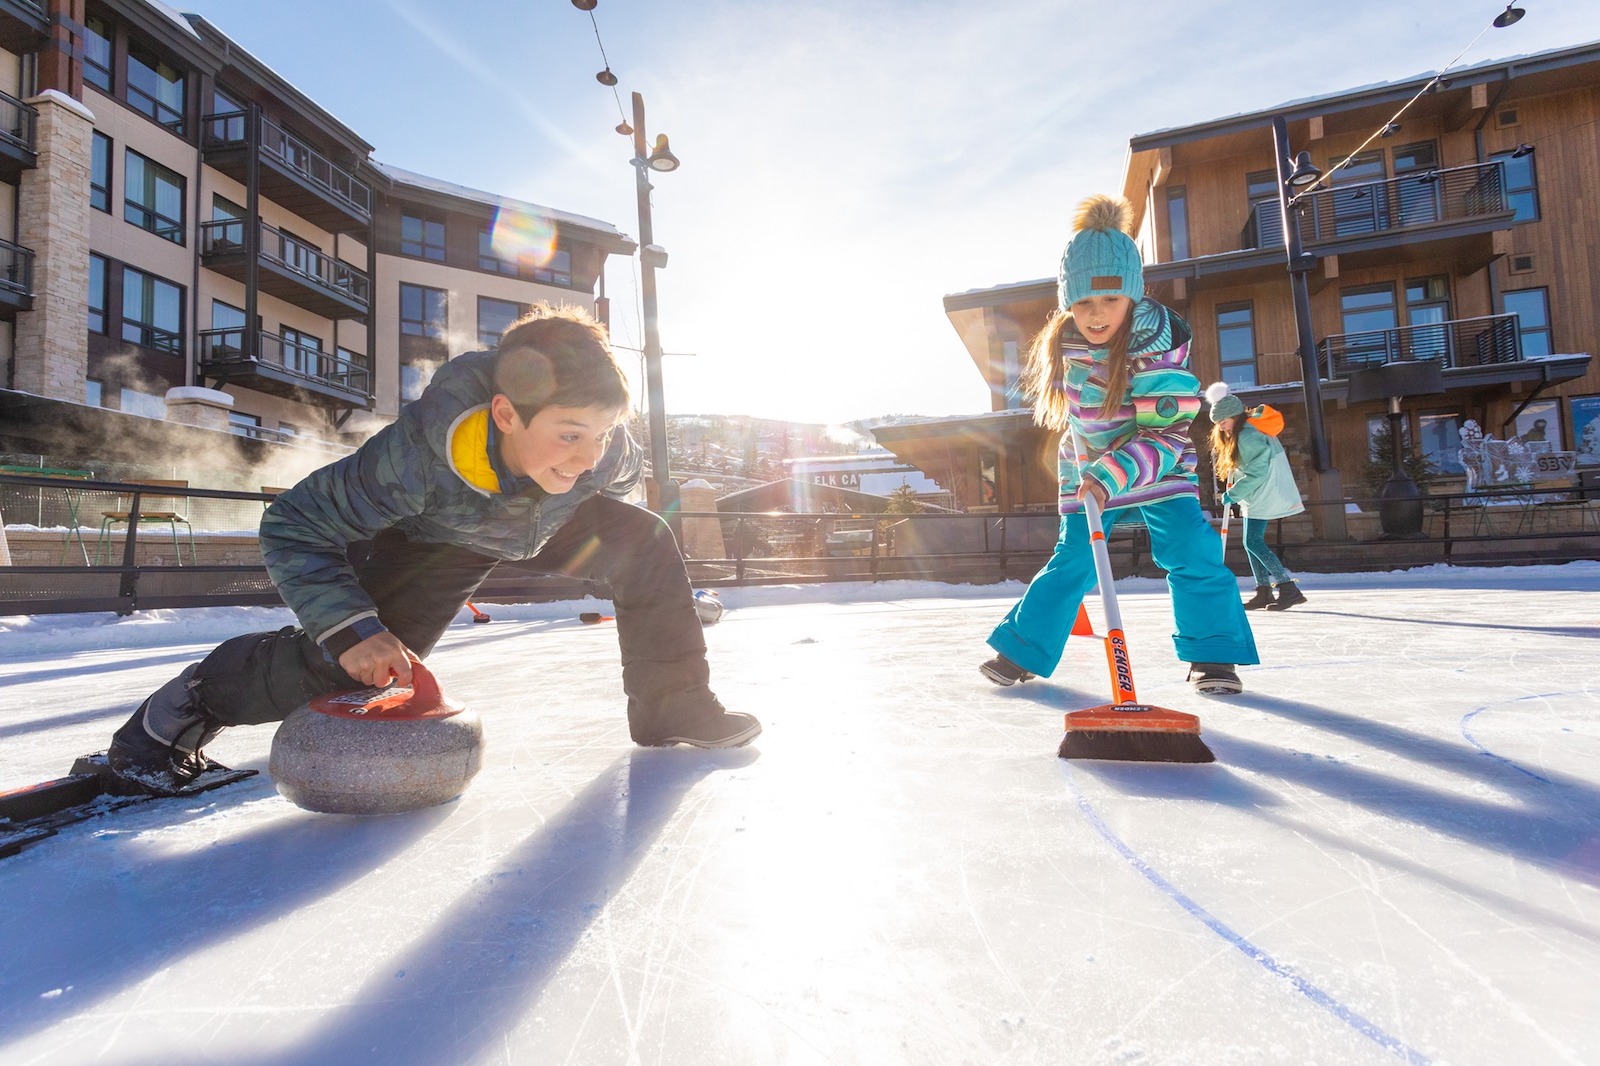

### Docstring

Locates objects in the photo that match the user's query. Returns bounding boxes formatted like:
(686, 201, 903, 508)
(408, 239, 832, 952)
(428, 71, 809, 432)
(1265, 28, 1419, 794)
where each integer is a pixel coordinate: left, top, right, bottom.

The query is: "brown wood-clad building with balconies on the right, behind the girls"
(928, 42, 1600, 509)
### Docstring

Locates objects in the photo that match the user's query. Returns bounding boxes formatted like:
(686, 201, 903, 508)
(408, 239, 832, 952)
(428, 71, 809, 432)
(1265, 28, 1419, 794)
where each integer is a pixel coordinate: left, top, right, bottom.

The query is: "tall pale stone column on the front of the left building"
(16, 90, 94, 403)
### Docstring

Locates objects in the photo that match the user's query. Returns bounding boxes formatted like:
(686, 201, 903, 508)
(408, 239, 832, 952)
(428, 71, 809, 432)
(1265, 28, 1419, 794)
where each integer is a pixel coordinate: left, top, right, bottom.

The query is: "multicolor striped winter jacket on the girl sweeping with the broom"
(1059, 298, 1200, 514)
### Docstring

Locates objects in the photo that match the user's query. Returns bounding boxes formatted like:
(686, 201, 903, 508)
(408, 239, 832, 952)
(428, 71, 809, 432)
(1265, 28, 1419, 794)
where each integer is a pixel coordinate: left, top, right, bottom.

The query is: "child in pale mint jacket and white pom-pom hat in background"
(1205, 381, 1306, 611)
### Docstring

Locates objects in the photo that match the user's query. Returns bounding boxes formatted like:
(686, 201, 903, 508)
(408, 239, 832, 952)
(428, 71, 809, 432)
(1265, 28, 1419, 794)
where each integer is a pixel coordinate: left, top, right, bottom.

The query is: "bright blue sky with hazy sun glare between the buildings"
(174, 0, 1600, 423)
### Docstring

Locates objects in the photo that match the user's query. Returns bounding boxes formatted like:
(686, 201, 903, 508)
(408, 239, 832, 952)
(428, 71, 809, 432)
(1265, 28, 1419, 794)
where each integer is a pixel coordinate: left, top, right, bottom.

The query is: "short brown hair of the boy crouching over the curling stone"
(494, 304, 629, 424)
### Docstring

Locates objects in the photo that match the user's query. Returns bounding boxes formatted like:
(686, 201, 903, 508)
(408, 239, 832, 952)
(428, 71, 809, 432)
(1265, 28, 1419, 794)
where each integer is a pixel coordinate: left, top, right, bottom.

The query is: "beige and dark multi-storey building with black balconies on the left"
(0, 0, 635, 482)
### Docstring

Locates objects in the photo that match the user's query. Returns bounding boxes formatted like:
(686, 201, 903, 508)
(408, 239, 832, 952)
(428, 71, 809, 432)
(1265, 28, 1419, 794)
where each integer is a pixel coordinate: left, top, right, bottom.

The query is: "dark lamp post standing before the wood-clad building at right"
(1272, 115, 1347, 541)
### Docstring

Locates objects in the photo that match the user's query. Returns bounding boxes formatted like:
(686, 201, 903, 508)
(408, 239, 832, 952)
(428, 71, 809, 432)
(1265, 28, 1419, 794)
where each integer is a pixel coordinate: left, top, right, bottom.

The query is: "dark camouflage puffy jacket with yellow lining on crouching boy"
(261, 352, 643, 640)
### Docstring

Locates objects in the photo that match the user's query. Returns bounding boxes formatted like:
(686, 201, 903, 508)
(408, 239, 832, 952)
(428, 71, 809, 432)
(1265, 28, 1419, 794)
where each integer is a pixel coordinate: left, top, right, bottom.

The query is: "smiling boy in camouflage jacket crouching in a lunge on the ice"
(107, 304, 762, 794)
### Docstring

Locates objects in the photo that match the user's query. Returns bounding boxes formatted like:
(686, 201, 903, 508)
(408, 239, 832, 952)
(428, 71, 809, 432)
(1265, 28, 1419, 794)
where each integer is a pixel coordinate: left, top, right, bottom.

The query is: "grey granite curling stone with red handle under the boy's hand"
(267, 663, 483, 815)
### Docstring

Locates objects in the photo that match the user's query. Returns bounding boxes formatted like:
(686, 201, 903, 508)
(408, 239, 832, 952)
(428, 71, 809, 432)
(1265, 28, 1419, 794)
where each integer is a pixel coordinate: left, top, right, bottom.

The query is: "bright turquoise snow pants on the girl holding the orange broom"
(989, 496, 1261, 677)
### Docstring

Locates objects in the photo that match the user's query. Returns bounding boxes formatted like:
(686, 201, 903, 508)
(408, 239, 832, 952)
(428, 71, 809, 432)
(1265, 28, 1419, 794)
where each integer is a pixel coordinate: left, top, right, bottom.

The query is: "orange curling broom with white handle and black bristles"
(1056, 432, 1216, 762)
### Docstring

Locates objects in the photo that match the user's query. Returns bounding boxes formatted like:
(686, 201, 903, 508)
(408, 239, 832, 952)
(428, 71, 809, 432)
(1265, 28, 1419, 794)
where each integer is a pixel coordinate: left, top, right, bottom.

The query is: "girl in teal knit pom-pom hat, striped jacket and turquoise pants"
(979, 195, 1259, 695)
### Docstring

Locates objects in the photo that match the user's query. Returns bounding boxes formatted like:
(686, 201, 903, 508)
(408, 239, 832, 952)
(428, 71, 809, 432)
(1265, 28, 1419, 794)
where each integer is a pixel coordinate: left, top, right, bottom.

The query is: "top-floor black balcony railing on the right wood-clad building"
(1240, 160, 1510, 248)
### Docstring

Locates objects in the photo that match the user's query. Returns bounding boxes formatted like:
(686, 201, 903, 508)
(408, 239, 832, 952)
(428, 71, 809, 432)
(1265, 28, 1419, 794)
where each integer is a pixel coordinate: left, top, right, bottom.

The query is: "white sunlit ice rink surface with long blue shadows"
(0, 563, 1600, 1066)
